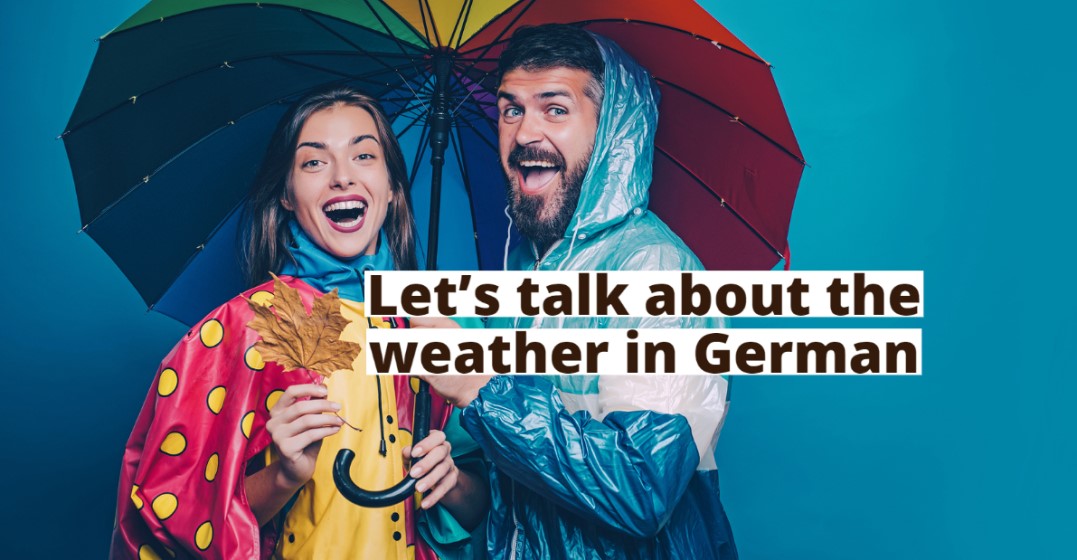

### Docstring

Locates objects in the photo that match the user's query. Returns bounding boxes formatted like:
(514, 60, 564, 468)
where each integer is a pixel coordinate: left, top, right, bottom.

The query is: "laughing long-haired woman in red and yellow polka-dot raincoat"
(112, 88, 487, 558)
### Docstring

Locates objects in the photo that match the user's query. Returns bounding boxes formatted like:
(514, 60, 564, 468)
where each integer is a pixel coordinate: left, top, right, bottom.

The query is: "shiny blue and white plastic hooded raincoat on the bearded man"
(462, 37, 737, 559)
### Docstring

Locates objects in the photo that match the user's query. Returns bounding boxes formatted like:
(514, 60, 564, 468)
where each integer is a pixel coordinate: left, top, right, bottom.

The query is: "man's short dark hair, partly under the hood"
(498, 24, 605, 112)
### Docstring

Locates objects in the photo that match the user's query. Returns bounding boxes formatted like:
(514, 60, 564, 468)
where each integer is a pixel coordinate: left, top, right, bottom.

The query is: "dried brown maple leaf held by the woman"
(247, 276, 360, 377)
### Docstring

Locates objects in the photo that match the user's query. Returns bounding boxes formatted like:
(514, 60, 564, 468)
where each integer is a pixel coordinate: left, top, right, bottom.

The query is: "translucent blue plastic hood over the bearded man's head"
(564, 34, 659, 239)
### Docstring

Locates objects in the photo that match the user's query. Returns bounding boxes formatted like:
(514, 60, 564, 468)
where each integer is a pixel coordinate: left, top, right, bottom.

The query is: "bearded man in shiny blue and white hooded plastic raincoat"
(430, 25, 737, 559)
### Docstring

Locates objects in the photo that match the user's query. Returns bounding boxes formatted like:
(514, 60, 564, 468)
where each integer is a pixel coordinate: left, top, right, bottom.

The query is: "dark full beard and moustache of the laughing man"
(502, 145, 595, 248)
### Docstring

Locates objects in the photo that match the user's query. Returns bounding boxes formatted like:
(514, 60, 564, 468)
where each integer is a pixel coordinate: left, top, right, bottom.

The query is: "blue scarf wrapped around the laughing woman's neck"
(280, 219, 393, 302)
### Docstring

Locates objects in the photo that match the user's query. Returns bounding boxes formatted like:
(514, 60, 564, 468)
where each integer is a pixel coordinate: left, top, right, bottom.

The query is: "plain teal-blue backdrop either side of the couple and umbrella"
(0, 0, 1077, 559)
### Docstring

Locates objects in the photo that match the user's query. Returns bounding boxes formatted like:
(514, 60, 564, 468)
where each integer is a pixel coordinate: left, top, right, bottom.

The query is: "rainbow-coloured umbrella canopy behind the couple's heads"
(62, 0, 803, 324)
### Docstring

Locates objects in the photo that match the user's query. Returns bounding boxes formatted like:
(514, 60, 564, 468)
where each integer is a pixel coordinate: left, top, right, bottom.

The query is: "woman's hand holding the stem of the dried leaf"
(266, 383, 344, 488)
